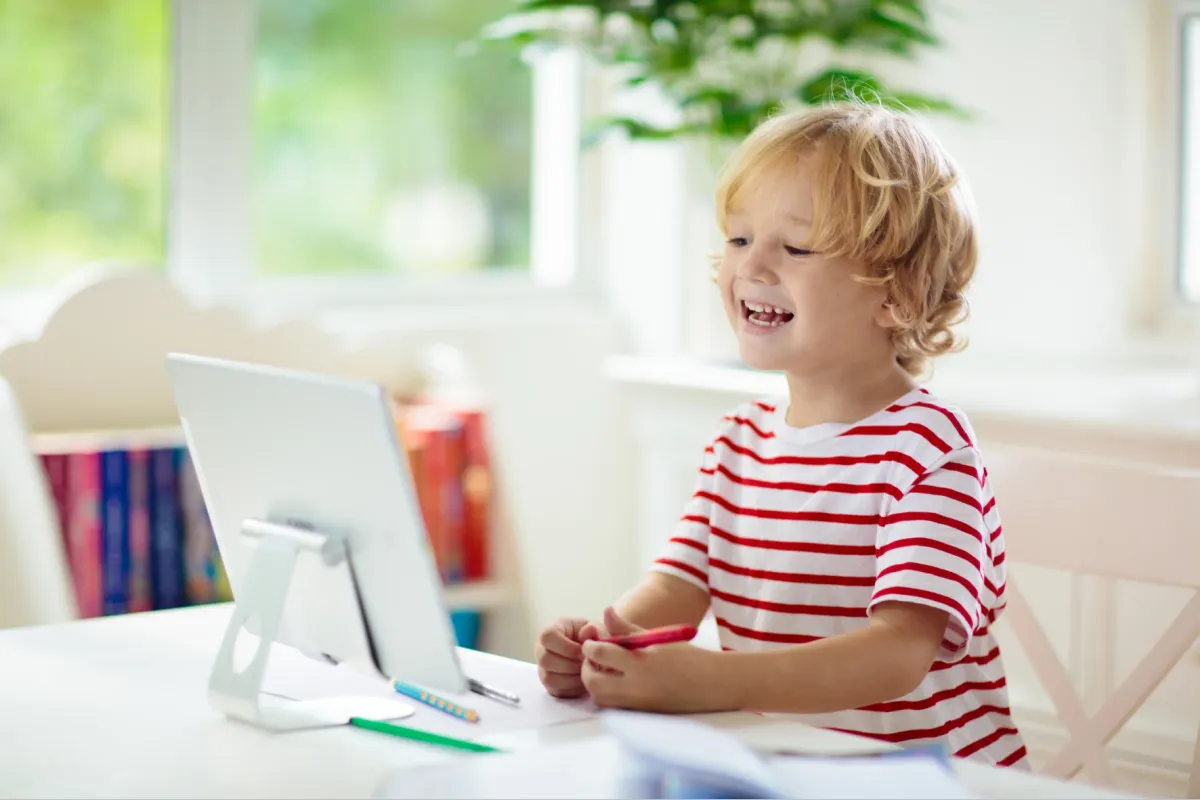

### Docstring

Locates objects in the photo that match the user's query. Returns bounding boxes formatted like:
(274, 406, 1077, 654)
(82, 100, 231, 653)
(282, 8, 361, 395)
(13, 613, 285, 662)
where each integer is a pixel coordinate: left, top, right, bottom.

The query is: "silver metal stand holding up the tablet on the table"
(209, 519, 414, 730)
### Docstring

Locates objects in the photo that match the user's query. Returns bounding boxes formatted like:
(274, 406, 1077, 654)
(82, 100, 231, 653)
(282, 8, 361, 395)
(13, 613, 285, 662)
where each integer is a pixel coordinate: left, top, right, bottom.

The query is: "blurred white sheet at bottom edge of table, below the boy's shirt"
(770, 756, 977, 800)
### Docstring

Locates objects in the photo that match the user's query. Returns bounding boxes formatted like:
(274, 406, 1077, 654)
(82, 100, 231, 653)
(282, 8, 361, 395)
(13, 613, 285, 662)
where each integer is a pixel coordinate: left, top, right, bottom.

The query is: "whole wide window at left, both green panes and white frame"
(0, 0, 582, 315)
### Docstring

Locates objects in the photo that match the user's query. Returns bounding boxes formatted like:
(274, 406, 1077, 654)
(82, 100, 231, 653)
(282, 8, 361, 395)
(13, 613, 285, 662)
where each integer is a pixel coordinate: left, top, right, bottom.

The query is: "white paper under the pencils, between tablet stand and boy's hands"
(263, 646, 596, 740)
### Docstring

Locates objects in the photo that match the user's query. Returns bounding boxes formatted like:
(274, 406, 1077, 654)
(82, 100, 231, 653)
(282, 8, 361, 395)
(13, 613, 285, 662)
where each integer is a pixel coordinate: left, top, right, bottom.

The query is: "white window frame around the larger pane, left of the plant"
(0, 0, 590, 335)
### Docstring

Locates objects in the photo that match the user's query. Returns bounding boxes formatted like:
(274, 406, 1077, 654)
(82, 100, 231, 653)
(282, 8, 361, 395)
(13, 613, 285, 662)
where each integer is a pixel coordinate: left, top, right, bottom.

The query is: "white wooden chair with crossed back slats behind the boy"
(984, 446, 1200, 798)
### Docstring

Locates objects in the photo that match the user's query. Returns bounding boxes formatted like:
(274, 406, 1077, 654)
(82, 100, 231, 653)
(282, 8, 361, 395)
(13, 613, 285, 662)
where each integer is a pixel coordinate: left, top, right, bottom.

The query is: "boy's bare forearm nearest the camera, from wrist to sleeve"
(714, 602, 947, 714)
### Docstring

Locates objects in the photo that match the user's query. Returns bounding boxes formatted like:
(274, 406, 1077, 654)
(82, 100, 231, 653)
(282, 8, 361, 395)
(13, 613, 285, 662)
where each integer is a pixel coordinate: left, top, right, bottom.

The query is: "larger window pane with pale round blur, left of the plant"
(252, 0, 533, 275)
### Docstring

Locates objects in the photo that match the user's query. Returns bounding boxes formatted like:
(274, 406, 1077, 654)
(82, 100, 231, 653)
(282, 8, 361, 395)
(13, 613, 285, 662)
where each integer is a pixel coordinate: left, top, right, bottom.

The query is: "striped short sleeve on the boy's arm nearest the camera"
(869, 447, 996, 661)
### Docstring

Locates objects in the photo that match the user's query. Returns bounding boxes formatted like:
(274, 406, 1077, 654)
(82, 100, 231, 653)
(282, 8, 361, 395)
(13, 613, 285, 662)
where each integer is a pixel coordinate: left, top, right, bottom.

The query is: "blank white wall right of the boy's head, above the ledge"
(900, 0, 1171, 367)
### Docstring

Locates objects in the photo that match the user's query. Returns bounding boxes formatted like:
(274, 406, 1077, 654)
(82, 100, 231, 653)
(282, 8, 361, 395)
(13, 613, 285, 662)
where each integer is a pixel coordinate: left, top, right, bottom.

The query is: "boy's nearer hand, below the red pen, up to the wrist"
(582, 640, 734, 714)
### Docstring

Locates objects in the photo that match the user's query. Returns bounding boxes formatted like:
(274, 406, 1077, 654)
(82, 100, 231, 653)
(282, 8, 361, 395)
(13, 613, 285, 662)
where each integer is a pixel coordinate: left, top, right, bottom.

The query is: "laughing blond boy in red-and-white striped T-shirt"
(538, 104, 1027, 766)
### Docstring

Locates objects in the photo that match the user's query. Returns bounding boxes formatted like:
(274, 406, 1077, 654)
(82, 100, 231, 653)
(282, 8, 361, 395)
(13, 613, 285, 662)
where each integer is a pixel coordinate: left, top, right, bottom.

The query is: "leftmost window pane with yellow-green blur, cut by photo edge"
(0, 0, 169, 287)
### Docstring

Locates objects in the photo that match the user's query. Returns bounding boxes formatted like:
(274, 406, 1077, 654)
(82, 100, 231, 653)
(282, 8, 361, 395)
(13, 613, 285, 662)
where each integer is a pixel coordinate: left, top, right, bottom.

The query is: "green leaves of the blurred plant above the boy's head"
(480, 0, 970, 144)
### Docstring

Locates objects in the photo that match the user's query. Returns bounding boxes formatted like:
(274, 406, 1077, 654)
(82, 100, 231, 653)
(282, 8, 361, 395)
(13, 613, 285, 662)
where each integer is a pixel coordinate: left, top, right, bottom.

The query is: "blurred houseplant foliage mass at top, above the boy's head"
(491, 0, 965, 139)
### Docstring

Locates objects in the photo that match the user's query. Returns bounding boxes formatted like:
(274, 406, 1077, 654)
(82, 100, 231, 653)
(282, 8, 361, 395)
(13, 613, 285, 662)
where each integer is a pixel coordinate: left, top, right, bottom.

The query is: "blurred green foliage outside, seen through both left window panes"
(0, 0, 532, 285)
